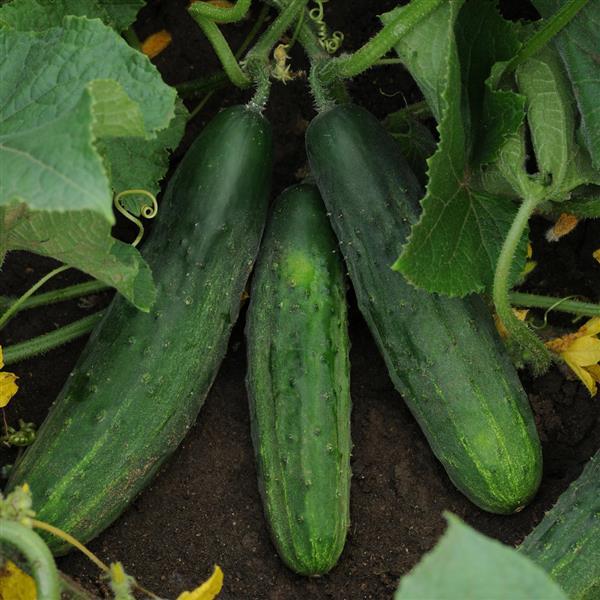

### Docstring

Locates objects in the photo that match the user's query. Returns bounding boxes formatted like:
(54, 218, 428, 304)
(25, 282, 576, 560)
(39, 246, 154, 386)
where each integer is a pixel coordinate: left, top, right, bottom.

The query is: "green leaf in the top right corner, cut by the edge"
(533, 0, 600, 170)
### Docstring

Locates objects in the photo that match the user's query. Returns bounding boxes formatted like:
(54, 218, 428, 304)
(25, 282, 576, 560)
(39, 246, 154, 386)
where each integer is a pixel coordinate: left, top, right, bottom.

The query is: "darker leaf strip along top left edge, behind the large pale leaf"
(0, 0, 144, 31)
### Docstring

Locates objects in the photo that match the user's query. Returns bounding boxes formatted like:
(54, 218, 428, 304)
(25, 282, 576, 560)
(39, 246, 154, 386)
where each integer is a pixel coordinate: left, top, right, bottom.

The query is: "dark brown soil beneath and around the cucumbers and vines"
(0, 0, 600, 600)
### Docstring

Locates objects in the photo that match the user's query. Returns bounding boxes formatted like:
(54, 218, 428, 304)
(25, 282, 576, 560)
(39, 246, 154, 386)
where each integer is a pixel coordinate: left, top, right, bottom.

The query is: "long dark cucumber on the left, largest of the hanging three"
(8, 106, 272, 554)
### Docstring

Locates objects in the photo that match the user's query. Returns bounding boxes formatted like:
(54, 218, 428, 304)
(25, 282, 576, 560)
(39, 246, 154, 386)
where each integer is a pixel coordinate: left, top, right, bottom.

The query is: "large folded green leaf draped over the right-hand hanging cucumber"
(383, 0, 525, 296)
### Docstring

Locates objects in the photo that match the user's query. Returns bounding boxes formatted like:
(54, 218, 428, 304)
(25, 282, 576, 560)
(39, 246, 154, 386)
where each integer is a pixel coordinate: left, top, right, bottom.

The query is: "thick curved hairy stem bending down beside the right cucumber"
(493, 195, 551, 373)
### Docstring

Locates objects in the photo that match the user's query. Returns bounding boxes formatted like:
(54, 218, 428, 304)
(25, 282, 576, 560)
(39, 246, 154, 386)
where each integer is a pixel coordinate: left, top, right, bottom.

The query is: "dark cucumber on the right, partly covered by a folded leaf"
(306, 105, 542, 513)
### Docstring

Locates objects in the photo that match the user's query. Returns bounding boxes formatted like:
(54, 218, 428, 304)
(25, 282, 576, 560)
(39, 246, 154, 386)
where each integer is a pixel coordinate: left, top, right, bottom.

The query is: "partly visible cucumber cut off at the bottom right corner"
(519, 451, 600, 600)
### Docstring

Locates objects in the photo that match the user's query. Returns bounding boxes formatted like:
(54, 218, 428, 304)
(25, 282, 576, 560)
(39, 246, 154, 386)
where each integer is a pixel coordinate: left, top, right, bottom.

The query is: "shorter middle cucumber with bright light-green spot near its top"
(246, 184, 351, 575)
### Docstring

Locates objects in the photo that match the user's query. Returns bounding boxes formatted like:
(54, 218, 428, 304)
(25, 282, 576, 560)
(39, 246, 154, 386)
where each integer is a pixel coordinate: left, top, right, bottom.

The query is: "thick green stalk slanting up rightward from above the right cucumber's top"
(321, 0, 444, 85)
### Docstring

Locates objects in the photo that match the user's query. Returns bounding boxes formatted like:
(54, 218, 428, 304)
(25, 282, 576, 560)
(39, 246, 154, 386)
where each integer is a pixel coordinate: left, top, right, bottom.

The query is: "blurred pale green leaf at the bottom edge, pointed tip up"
(394, 514, 568, 600)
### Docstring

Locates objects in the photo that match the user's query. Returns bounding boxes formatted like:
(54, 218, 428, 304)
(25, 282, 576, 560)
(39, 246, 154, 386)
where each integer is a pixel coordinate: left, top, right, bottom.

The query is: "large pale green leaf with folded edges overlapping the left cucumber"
(0, 16, 176, 310)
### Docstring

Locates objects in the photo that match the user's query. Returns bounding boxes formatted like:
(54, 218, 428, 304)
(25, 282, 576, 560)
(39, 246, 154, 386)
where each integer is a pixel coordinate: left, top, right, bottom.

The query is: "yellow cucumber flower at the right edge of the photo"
(546, 317, 600, 396)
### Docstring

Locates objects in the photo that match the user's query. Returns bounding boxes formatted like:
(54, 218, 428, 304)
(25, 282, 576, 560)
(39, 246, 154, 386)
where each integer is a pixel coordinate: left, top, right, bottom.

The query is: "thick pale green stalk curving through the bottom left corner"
(0, 519, 60, 600)
